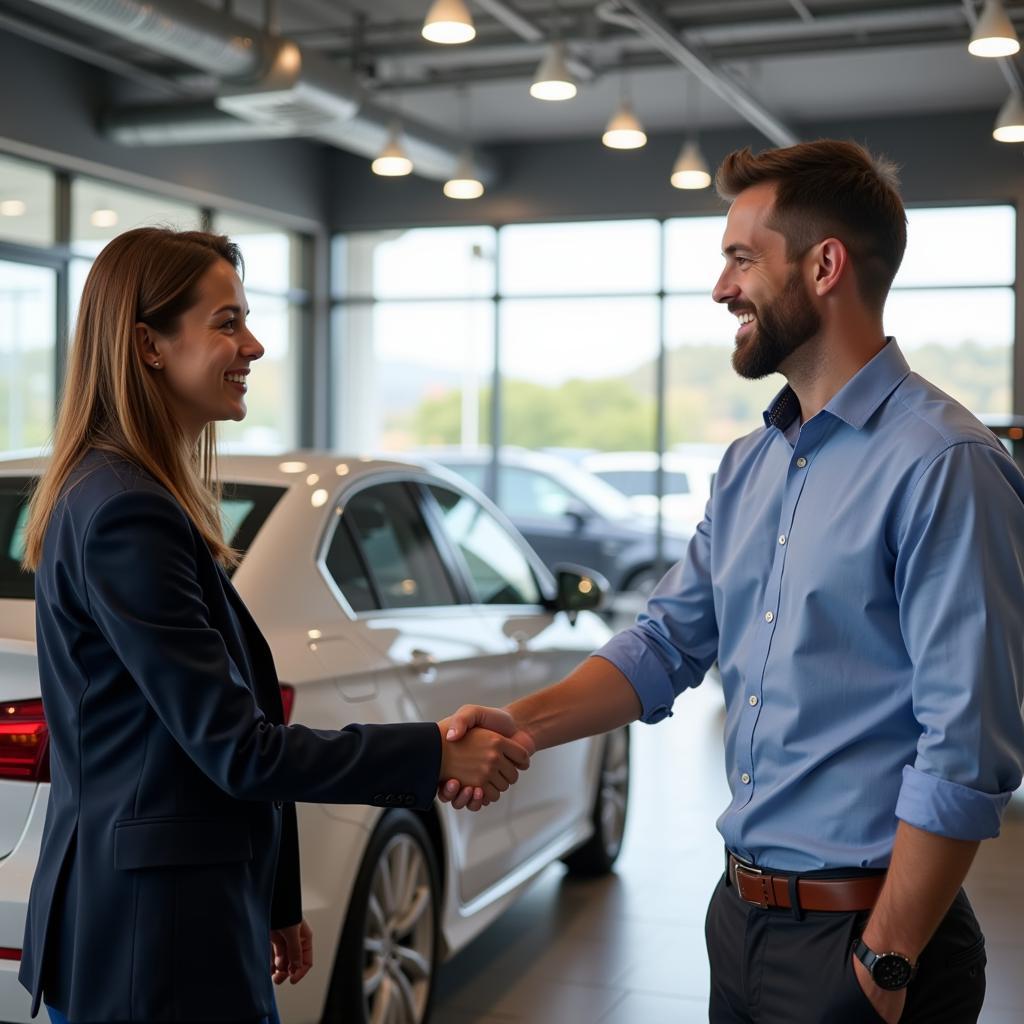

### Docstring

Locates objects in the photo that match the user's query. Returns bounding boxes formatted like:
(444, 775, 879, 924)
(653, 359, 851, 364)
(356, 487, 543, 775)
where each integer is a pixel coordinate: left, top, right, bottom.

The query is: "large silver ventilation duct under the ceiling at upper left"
(29, 0, 495, 184)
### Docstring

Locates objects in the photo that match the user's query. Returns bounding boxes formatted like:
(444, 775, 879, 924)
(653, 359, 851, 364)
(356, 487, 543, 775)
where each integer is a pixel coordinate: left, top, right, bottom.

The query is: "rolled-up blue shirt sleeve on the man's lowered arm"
(895, 441, 1024, 840)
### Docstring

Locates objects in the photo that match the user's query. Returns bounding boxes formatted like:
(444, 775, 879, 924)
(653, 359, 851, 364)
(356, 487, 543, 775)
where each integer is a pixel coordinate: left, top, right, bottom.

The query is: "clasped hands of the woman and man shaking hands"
(437, 705, 537, 811)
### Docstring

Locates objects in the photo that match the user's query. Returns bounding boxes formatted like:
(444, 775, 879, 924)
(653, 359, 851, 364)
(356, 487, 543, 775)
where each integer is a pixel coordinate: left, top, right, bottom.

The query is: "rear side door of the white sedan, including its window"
(325, 479, 515, 902)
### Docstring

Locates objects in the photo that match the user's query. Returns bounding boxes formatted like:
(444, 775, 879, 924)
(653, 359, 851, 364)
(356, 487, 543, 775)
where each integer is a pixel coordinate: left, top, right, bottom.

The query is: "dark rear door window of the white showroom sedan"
(339, 483, 458, 608)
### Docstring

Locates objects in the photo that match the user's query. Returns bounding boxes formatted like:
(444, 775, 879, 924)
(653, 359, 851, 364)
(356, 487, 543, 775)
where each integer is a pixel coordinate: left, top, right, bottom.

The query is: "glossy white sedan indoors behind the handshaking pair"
(0, 453, 629, 1024)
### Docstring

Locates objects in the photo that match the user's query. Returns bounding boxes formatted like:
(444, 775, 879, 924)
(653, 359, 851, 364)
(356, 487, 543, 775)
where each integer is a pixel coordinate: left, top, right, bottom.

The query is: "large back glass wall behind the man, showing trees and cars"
(333, 207, 1015, 610)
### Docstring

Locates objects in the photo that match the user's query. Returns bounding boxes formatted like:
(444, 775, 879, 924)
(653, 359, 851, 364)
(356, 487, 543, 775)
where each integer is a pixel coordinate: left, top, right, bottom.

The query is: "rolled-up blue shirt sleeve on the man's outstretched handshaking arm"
(595, 502, 718, 725)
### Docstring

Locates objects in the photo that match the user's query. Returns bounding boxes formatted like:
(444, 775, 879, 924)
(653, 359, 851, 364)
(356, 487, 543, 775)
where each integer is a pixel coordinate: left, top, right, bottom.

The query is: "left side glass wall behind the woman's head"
(0, 149, 310, 455)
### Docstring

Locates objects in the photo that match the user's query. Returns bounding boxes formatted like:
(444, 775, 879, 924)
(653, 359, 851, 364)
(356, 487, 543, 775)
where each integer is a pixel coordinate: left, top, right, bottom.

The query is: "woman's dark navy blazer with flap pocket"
(19, 452, 440, 1022)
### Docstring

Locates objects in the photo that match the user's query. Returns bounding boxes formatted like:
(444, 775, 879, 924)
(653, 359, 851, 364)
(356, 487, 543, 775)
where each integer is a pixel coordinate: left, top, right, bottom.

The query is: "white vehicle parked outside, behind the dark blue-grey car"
(580, 445, 722, 527)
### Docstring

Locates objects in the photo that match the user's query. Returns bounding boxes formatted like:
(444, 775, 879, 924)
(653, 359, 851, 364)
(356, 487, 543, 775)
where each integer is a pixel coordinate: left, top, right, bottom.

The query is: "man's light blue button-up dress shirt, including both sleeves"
(598, 339, 1024, 871)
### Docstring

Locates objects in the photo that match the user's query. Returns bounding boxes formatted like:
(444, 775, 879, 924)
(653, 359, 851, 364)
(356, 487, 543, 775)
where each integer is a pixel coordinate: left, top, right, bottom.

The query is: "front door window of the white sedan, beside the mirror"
(429, 485, 541, 604)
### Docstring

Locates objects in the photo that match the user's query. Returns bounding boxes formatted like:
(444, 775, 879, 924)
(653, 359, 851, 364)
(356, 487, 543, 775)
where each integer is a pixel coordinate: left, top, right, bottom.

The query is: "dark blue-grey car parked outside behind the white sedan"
(418, 447, 693, 617)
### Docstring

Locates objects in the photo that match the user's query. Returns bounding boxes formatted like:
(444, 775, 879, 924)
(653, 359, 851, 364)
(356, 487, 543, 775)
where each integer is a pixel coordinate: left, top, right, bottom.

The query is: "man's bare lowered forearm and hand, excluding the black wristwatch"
(853, 821, 980, 1022)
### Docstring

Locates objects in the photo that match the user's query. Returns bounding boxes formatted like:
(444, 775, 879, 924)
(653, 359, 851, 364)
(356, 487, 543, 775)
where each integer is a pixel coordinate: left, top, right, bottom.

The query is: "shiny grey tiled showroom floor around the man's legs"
(434, 685, 1024, 1024)
